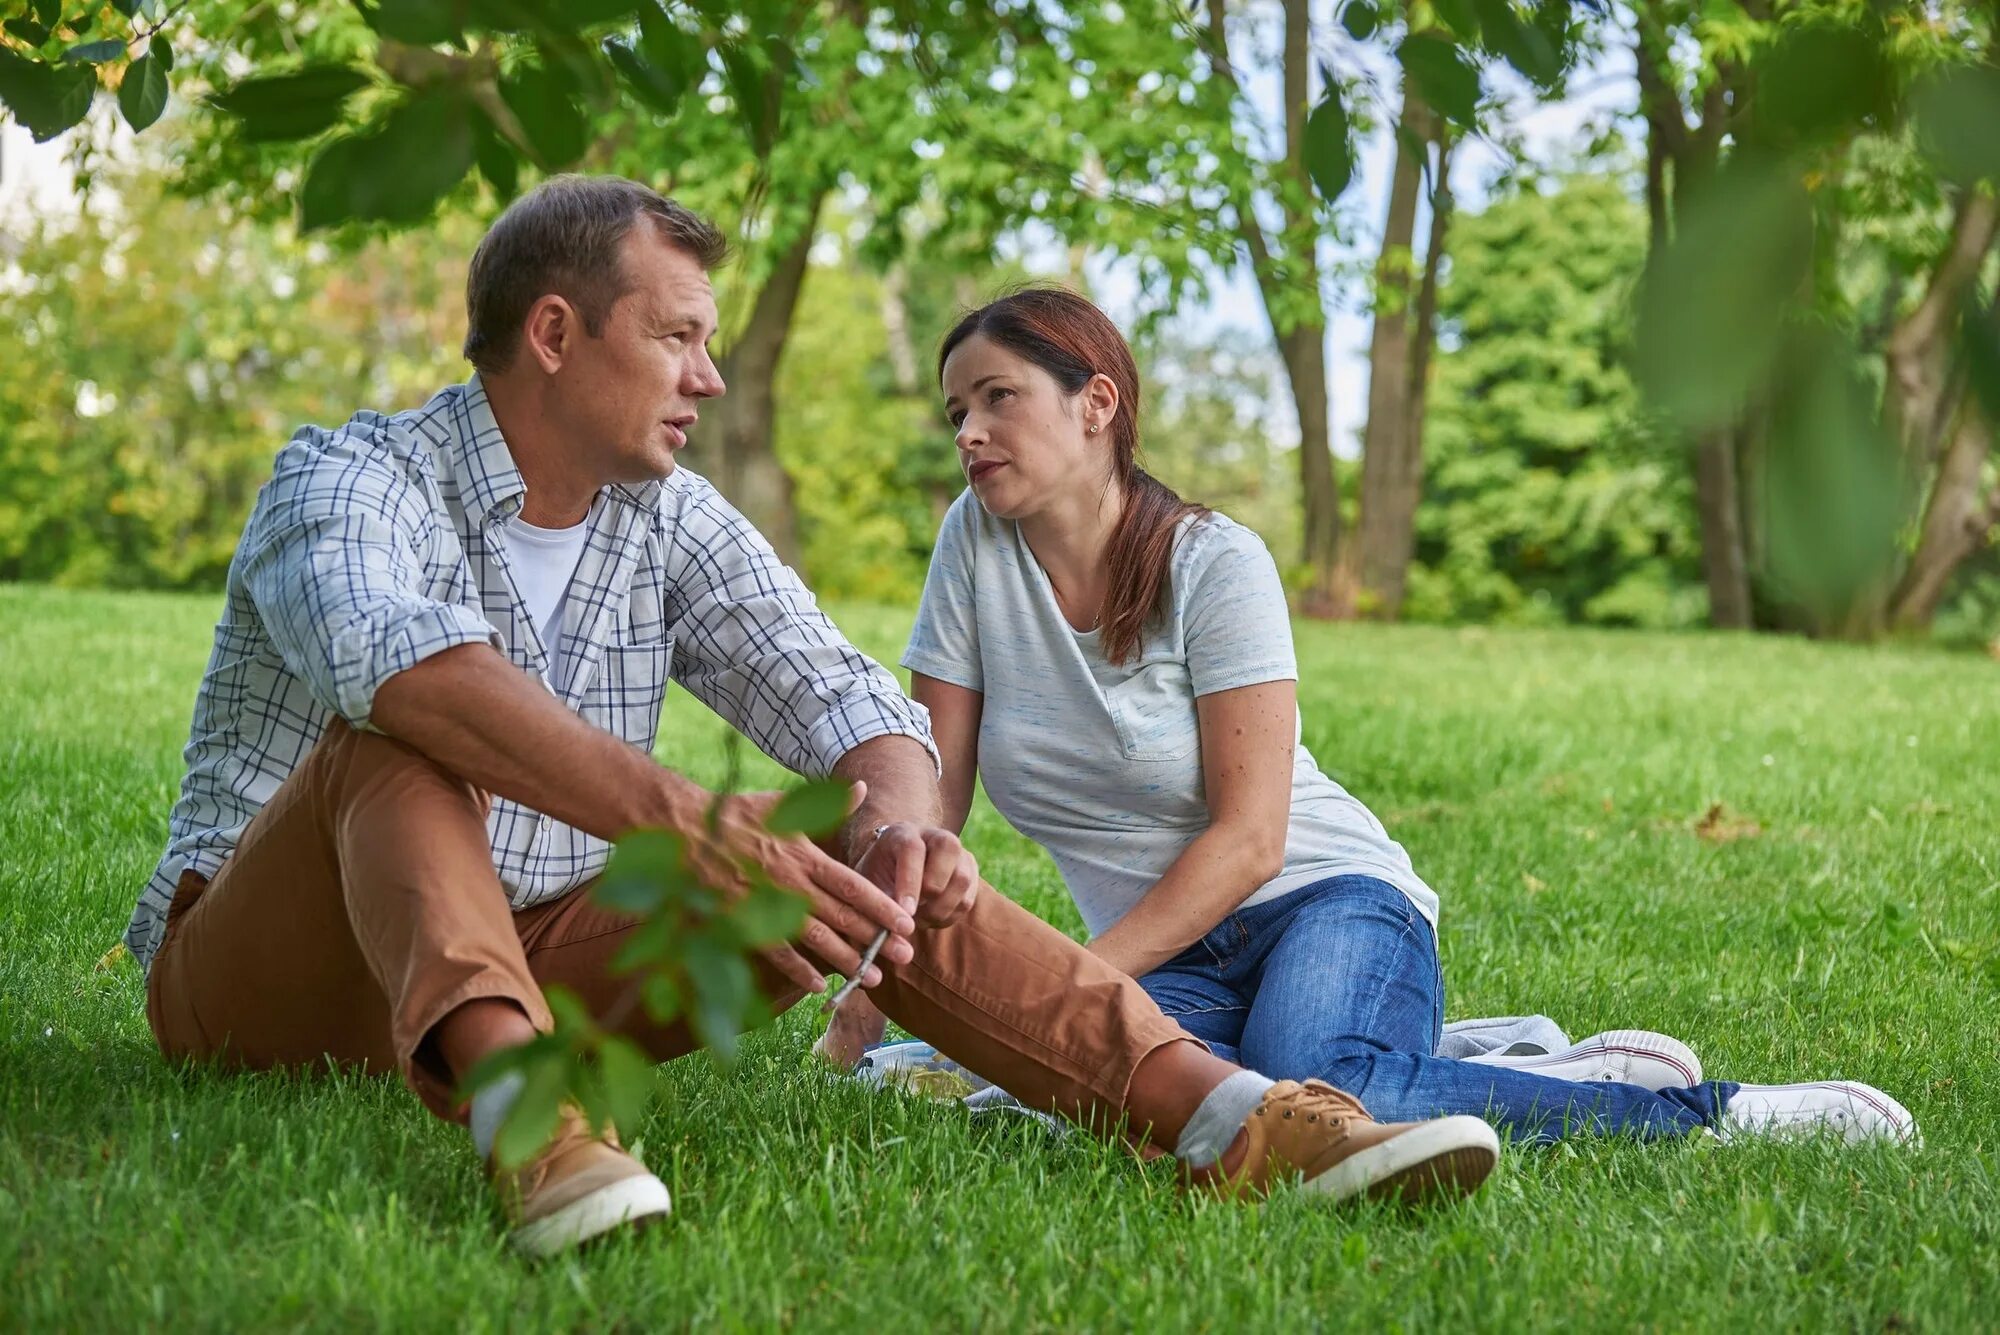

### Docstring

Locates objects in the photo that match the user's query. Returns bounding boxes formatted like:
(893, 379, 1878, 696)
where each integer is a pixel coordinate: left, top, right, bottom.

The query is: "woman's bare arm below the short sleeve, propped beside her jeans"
(1080, 681, 1298, 977)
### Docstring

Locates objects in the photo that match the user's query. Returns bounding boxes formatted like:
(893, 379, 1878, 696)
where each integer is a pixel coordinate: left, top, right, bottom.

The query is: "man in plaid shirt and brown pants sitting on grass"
(126, 176, 1496, 1253)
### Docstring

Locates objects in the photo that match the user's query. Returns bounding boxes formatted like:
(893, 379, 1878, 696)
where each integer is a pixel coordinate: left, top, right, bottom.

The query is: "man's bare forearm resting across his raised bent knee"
(370, 646, 712, 839)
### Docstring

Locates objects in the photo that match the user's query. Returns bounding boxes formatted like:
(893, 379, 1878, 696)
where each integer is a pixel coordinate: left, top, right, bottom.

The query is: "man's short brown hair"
(466, 176, 730, 374)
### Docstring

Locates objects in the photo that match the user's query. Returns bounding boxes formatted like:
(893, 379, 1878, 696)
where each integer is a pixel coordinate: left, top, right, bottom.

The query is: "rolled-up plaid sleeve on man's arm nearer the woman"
(664, 476, 938, 777)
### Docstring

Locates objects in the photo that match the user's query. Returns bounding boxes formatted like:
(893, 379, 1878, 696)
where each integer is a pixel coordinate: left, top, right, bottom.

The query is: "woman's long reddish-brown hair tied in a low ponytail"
(938, 288, 1208, 664)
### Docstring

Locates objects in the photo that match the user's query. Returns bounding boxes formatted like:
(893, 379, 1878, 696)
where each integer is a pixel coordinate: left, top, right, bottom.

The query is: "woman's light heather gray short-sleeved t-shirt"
(902, 492, 1438, 935)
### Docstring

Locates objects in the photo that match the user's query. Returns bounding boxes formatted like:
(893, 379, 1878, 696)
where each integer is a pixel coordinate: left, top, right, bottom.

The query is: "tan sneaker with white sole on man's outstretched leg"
(1204, 1079, 1500, 1205)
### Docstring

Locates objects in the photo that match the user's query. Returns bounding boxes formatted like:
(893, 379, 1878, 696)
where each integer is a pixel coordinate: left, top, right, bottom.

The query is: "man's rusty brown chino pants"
(146, 721, 1190, 1117)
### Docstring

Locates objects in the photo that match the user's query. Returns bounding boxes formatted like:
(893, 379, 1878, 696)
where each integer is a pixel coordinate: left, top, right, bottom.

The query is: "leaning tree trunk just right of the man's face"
(696, 196, 824, 566)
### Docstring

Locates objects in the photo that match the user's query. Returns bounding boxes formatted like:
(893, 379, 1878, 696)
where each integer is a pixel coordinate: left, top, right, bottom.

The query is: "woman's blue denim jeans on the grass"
(1140, 875, 1736, 1141)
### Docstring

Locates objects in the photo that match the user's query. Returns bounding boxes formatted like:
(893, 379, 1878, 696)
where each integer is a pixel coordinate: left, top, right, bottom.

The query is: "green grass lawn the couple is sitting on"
(0, 588, 2000, 1329)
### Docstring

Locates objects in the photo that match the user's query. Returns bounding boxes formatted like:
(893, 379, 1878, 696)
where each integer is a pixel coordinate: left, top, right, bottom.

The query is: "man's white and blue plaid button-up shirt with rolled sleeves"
(126, 376, 936, 967)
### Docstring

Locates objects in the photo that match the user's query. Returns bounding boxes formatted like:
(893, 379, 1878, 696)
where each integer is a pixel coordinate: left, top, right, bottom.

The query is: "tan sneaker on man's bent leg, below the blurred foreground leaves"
(494, 1107, 672, 1257)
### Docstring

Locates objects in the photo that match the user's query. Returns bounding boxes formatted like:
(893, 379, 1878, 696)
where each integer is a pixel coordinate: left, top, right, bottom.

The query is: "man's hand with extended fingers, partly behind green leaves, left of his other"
(688, 793, 916, 991)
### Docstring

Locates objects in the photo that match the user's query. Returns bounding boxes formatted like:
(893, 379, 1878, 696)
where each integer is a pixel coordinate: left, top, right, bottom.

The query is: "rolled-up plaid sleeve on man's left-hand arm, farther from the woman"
(242, 432, 498, 729)
